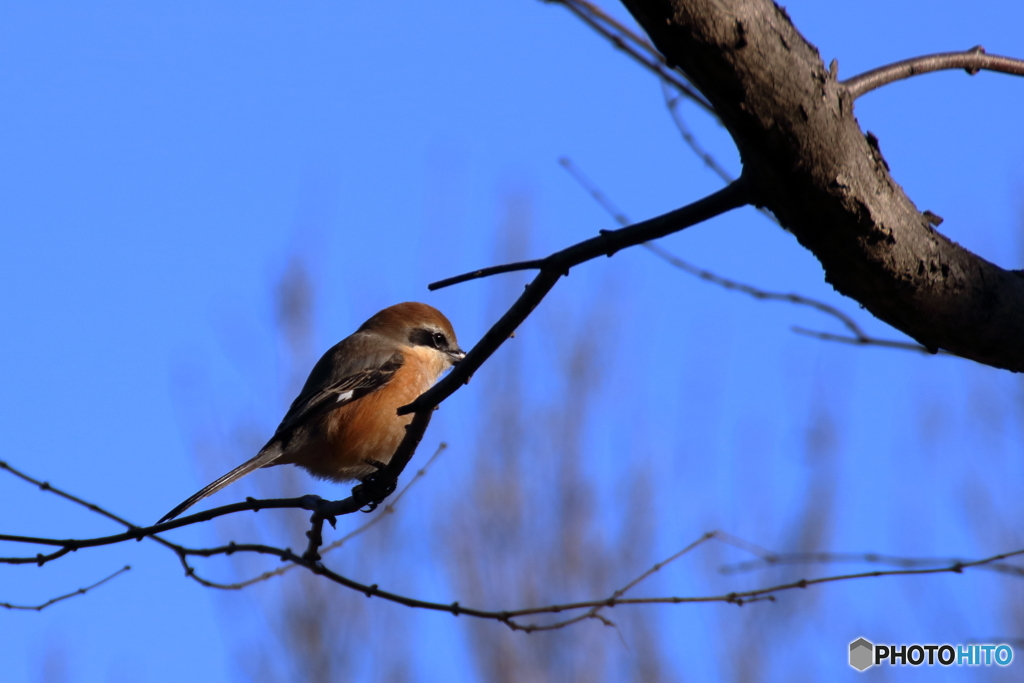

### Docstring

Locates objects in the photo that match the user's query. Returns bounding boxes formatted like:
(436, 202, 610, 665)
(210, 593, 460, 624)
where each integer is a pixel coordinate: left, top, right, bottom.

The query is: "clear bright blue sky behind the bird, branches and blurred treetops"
(0, 0, 1024, 682)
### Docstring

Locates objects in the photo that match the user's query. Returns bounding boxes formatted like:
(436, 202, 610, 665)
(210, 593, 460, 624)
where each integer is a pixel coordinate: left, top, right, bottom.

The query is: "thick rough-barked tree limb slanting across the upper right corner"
(623, 0, 1024, 372)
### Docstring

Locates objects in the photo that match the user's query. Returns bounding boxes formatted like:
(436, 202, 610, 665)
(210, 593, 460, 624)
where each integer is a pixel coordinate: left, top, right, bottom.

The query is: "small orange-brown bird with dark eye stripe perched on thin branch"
(157, 301, 466, 524)
